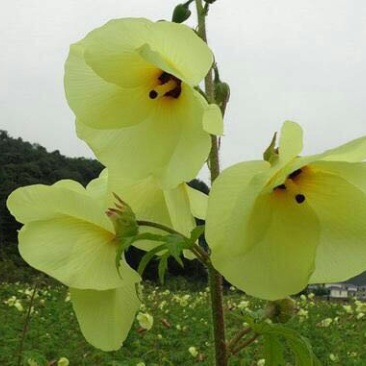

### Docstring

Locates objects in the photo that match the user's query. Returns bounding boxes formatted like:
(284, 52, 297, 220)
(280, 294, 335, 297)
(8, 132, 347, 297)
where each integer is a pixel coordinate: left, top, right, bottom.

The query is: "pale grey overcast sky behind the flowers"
(0, 0, 366, 182)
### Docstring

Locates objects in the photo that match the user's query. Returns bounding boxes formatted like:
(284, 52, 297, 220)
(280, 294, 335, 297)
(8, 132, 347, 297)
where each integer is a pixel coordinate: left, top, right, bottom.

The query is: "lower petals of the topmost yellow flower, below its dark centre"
(77, 85, 211, 189)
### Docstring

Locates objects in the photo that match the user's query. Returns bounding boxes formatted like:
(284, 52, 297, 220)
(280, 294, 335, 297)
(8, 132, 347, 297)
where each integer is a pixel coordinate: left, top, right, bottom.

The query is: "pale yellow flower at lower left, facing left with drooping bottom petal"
(7, 180, 140, 351)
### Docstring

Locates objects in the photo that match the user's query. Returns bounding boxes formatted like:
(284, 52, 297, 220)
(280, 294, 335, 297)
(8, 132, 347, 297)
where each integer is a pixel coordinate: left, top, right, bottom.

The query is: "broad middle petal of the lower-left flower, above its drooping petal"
(19, 217, 139, 290)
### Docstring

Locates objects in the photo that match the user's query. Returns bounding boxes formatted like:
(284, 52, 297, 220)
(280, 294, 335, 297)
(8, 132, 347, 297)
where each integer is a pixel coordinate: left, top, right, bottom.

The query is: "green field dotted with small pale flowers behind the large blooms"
(0, 283, 366, 366)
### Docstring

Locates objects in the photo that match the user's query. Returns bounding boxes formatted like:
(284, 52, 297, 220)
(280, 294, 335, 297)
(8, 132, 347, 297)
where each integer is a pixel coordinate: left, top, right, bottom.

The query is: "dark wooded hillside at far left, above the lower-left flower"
(0, 130, 103, 255)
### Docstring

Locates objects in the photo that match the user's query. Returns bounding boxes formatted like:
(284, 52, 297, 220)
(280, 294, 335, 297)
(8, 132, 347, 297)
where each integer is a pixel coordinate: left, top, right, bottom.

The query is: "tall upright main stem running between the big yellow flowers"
(196, 0, 228, 366)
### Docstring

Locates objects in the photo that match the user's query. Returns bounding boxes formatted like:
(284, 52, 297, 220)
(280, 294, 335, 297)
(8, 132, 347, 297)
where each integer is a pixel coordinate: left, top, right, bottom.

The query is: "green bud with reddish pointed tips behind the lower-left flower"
(106, 193, 138, 239)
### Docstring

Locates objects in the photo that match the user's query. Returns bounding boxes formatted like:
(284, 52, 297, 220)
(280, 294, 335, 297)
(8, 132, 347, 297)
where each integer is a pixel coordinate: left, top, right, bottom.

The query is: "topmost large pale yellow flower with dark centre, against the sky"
(65, 18, 222, 188)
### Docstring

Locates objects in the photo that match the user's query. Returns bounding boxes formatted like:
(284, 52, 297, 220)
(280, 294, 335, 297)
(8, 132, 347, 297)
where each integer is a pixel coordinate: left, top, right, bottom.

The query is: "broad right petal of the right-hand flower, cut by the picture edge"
(302, 163, 366, 283)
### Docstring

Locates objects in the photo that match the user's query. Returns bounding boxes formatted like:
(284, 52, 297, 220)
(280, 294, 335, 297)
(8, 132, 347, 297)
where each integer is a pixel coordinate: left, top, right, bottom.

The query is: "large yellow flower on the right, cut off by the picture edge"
(206, 121, 366, 300)
